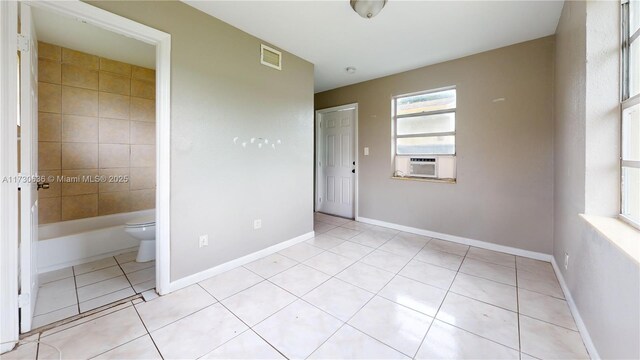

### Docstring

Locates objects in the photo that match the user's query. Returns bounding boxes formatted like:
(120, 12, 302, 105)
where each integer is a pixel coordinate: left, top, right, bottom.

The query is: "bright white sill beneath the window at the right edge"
(580, 214, 640, 263)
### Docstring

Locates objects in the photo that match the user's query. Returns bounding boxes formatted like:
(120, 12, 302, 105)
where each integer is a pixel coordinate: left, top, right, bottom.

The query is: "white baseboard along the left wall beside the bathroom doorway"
(168, 231, 315, 293)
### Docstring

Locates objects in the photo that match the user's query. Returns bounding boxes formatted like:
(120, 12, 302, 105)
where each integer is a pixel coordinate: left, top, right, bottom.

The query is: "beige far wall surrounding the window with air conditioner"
(315, 37, 554, 254)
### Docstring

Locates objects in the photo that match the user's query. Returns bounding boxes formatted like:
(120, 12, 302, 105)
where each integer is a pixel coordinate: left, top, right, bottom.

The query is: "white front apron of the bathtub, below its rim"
(38, 226, 140, 273)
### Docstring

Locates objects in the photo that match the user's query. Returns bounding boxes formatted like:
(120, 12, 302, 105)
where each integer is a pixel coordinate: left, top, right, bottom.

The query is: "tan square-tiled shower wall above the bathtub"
(38, 42, 156, 224)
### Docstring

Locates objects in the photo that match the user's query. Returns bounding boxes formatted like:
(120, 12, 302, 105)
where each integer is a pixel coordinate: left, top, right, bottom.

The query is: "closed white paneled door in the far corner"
(317, 108, 356, 218)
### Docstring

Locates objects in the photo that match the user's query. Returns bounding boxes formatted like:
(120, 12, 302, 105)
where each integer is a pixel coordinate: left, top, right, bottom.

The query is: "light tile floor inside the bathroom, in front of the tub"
(33, 251, 156, 328)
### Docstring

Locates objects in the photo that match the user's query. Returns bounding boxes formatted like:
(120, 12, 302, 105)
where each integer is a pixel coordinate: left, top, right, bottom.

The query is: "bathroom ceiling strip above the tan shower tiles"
(31, 6, 156, 69)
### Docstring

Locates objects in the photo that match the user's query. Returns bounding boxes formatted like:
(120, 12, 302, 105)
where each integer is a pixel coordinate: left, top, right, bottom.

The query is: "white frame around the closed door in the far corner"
(313, 103, 360, 220)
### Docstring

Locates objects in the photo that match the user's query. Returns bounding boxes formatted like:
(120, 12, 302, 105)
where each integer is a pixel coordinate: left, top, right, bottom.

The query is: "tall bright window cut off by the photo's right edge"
(620, 0, 640, 226)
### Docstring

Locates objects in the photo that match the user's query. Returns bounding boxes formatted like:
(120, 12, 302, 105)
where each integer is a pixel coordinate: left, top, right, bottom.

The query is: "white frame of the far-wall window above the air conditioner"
(391, 86, 458, 158)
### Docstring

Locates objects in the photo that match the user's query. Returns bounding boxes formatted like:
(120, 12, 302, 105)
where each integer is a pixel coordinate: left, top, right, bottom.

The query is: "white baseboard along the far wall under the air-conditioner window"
(356, 217, 553, 261)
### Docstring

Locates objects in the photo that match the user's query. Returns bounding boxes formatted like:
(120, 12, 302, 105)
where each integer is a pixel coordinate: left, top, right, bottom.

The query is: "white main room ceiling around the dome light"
(183, 0, 563, 92)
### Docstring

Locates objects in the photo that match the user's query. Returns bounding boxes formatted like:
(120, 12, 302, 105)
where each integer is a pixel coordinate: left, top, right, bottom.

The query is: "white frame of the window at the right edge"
(620, 0, 640, 228)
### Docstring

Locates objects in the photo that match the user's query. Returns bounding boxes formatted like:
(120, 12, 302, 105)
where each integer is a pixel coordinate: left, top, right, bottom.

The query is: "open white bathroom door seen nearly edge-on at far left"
(18, 3, 38, 333)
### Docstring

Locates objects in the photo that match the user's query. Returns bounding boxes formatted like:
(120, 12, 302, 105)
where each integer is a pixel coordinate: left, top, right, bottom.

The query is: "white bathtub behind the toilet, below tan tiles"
(38, 209, 155, 273)
